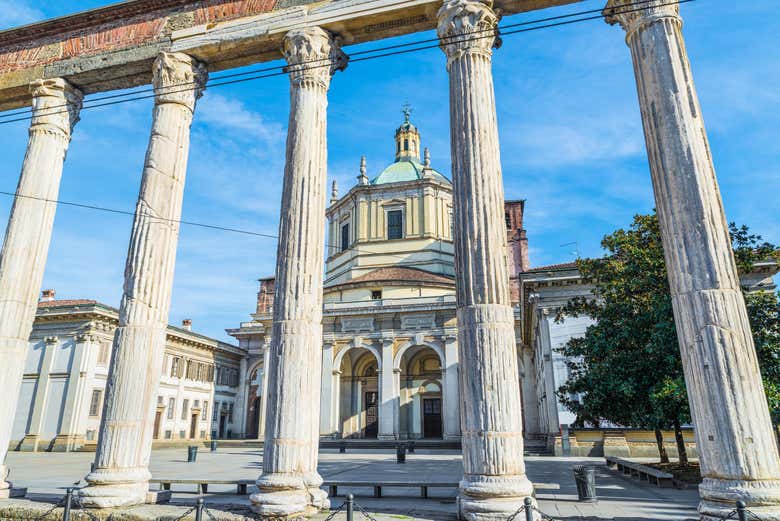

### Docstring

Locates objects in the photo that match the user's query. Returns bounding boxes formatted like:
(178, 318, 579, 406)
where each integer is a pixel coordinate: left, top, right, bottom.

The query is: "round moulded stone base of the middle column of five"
(249, 473, 330, 519)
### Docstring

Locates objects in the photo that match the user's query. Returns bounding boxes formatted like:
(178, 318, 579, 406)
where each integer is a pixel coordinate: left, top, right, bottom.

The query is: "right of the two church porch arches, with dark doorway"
(398, 345, 444, 439)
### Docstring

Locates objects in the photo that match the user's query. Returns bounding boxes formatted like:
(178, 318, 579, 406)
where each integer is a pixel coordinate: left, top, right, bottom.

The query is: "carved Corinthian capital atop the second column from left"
(152, 52, 208, 111)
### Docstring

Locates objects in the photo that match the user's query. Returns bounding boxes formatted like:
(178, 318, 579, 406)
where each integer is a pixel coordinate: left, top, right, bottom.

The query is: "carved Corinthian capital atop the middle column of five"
(282, 27, 349, 89)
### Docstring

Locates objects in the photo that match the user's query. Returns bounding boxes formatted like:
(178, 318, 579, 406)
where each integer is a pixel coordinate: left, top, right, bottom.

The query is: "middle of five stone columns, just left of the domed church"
(250, 27, 345, 518)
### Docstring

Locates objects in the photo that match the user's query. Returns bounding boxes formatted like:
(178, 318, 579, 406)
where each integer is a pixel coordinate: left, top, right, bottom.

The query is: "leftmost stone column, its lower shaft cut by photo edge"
(0, 78, 83, 498)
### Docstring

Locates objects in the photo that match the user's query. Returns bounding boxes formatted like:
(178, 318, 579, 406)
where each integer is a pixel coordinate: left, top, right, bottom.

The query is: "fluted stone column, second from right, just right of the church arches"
(438, 0, 533, 520)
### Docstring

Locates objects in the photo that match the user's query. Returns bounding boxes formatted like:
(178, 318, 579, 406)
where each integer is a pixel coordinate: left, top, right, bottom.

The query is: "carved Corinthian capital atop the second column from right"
(436, 0, 500, 66)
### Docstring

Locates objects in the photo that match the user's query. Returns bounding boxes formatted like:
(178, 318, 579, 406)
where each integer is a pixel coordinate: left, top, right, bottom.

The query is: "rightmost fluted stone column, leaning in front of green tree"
(605, 0, 780, 520)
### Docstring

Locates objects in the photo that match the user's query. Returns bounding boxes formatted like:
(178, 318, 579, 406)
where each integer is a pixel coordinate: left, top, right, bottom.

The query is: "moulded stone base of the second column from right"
(458, 475, 541, 521)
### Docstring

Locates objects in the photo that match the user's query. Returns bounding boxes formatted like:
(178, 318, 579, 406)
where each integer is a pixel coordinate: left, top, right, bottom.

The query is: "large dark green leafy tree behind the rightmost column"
(558, 214, 780, 464)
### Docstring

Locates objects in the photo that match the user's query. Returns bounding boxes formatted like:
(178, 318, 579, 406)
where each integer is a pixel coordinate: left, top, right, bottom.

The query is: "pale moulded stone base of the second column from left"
(78, 469, 151, 508)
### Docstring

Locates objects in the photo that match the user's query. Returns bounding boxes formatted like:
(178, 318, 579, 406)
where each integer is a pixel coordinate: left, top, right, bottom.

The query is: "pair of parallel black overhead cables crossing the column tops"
(0, 0, 695, 125)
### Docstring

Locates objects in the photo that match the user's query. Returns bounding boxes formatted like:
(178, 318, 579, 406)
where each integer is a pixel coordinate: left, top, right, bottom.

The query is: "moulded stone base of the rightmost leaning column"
(699, 478, 780, 521)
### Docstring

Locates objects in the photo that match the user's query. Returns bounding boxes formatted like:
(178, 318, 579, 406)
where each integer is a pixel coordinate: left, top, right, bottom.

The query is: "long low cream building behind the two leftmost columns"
(10, 290, 246, 451)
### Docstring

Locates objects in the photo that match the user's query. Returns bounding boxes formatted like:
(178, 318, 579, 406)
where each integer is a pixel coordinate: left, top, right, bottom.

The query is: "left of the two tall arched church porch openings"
(338, 347, 379, 438)
